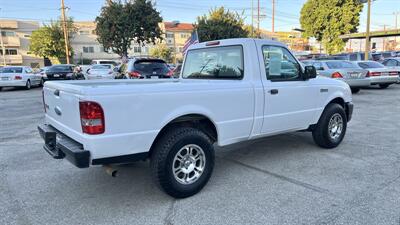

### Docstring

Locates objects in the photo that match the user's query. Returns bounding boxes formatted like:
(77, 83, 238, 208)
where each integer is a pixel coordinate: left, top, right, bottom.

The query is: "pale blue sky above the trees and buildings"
(0, 0, 400, 32)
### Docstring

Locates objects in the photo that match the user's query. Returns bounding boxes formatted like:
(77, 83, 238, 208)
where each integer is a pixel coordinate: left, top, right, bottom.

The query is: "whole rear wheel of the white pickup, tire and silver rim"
(151, 127, 214, 198)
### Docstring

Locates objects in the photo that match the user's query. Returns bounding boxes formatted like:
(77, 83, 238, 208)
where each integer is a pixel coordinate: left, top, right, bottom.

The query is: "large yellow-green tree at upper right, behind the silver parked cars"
(300, 0, 363, 54)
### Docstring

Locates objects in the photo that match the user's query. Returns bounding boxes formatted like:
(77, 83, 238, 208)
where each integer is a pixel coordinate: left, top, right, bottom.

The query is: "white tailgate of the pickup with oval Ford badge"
(43, 86, 82, 136)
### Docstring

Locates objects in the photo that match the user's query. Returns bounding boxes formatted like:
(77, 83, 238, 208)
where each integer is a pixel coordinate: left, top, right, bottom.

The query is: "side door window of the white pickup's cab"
(262, 46, 301, 81)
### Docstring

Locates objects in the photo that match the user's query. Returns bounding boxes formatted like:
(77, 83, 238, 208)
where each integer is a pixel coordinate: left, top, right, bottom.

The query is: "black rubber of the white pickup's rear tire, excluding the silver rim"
(151, 127, 214, 198)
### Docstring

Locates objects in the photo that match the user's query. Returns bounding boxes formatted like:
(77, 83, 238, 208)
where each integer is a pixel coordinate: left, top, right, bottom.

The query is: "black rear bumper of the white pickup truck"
(38, 124, 90, 168)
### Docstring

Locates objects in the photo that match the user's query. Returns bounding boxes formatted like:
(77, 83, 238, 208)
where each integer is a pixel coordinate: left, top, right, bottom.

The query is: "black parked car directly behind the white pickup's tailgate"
(45, 64, 84, 80)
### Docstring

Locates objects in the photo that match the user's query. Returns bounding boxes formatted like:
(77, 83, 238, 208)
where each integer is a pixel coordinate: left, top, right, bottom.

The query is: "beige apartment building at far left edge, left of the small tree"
(0, 19, 44, 68)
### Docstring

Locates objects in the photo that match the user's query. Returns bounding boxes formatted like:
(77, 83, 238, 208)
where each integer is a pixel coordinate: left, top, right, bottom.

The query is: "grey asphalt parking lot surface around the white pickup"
(0, 85, 400, 225)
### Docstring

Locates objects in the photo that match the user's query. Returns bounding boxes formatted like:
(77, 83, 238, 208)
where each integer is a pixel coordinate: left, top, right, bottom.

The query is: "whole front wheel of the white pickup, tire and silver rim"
(312, 103, 347, 148)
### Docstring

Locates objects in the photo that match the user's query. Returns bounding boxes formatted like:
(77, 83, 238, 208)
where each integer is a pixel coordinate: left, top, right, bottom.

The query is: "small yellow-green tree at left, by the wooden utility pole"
(29, 19, 76, 63)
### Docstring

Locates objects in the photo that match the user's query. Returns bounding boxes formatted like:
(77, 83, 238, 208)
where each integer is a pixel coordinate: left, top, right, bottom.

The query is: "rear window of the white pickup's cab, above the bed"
(182, 46, 244, 79)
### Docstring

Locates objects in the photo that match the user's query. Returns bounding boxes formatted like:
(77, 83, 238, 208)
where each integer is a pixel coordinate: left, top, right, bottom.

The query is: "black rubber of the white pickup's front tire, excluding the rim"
(312, 103, 347, 149)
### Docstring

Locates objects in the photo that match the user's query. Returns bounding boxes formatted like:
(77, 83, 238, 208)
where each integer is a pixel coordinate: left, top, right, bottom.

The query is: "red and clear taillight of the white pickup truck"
(79, 101, 105, 134)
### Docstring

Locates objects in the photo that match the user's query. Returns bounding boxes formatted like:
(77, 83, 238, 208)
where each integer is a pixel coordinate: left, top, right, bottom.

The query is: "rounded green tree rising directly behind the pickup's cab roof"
(195, 7, 249, 42)
